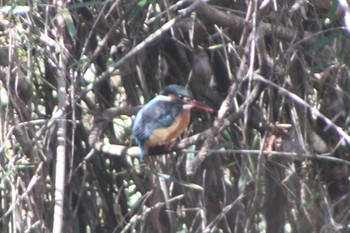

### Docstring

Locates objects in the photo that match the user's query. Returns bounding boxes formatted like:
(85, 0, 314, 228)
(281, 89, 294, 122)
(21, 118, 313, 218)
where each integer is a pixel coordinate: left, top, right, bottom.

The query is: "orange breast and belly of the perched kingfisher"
(147, 109, 191, 146)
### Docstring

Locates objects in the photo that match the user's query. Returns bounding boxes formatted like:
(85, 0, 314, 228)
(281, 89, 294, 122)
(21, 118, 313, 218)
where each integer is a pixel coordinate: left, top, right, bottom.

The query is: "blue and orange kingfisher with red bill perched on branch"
(132, 84, 215, 160)
